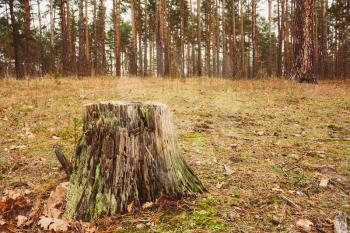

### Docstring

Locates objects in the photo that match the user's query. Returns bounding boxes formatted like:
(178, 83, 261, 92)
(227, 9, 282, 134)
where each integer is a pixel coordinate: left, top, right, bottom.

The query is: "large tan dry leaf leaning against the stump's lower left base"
(44, 182, 69, 218)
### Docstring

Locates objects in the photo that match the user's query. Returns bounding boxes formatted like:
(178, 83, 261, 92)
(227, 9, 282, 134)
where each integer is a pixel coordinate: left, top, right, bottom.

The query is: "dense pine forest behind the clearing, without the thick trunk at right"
(0, 0, 350, 79)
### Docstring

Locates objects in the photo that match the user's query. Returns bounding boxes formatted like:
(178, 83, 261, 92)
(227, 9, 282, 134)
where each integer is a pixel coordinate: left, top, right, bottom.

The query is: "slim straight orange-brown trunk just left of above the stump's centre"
(113, 0, 121, 77)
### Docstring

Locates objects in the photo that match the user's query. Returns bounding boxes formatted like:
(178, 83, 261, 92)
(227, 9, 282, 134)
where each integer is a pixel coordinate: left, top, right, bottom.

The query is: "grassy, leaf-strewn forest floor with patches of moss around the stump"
(0, 77, 350, 232)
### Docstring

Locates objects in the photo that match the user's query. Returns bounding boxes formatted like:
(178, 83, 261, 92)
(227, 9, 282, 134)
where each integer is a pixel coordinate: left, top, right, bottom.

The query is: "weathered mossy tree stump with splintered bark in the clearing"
(66, 101, 205, 220)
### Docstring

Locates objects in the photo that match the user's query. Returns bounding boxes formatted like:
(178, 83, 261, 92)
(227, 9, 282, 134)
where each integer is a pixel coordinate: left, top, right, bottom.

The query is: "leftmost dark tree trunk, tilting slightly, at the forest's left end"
(8, 0, 24, 79)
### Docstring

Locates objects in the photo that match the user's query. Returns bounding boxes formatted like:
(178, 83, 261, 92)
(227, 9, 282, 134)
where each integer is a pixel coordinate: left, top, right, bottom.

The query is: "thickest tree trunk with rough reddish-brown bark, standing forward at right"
(291, 0, 316, 83)
